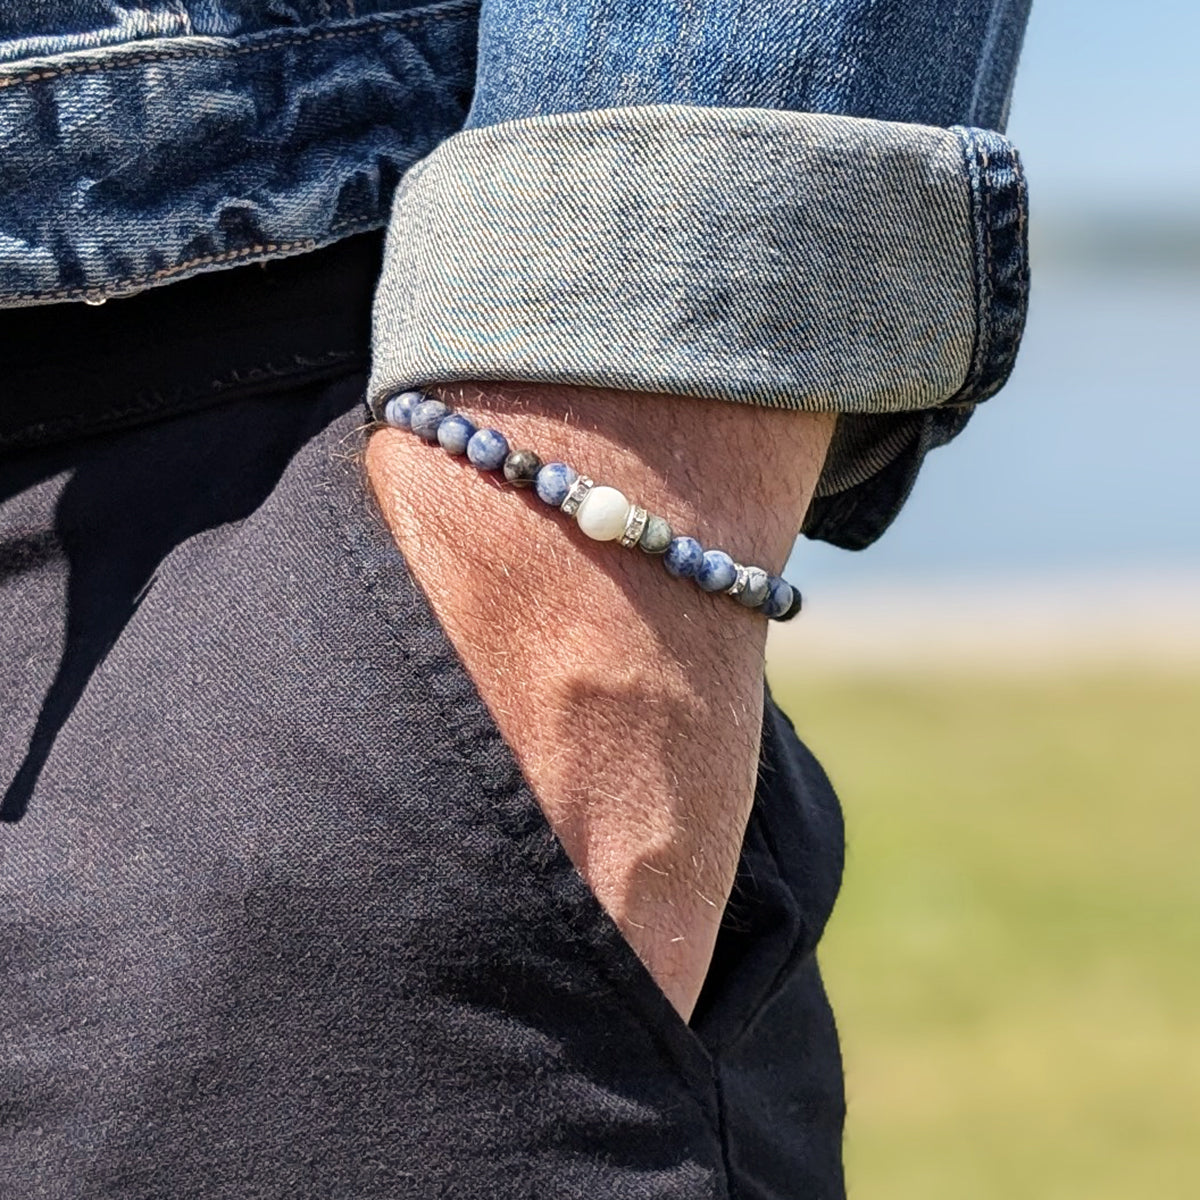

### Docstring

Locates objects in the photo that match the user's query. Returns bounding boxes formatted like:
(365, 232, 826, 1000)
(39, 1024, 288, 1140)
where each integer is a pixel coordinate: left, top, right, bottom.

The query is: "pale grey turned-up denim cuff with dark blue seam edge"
(371, 106, 1027, 546)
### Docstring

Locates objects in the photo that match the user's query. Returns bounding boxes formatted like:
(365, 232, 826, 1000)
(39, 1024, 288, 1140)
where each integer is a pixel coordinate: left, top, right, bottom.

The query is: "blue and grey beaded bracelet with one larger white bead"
(382, 391, 800, 620)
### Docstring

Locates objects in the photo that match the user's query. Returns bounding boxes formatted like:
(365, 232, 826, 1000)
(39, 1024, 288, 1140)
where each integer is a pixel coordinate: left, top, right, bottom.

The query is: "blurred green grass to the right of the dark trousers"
(768, 664, 1200, 1200)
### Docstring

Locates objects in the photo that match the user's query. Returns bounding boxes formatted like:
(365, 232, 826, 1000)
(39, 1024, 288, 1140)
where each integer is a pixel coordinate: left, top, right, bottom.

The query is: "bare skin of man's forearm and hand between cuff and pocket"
(367, 386, 833, 1014)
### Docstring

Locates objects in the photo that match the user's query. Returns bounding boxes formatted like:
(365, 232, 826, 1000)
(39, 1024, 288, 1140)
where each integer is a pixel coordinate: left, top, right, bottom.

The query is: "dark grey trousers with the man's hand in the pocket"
(0, 239, 842, 1200)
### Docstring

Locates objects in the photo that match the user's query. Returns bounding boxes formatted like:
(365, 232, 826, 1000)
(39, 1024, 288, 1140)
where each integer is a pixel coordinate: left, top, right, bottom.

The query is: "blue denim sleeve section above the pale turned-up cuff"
(469, 0, 1031, 131)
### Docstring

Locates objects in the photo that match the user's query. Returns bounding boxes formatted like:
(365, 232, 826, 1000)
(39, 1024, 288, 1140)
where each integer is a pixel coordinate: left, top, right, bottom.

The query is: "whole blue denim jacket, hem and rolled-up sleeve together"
(0, 0, 1028, 547)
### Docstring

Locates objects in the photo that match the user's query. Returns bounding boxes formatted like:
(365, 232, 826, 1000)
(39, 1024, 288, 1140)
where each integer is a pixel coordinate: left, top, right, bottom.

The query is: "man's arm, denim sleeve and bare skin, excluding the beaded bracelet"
(370, 0, 1028, 1013)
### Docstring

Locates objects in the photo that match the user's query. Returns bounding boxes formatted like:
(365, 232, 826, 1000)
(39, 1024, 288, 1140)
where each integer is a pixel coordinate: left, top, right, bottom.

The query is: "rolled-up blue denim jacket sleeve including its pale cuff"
(372, 0, 1028, 548)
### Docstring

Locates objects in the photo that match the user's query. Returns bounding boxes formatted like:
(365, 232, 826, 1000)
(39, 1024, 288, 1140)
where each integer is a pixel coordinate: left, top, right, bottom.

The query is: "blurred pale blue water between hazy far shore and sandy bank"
(791, 263, 1200, 592)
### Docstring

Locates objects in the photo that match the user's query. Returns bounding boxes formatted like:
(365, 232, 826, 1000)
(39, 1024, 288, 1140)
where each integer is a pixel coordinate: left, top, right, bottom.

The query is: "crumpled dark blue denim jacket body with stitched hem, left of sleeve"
(0, 0, 478, 306)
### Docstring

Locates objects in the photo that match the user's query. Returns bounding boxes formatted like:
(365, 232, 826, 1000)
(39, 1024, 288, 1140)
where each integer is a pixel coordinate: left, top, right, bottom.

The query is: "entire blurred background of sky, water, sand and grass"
(768, 0, 1200, 1200)
